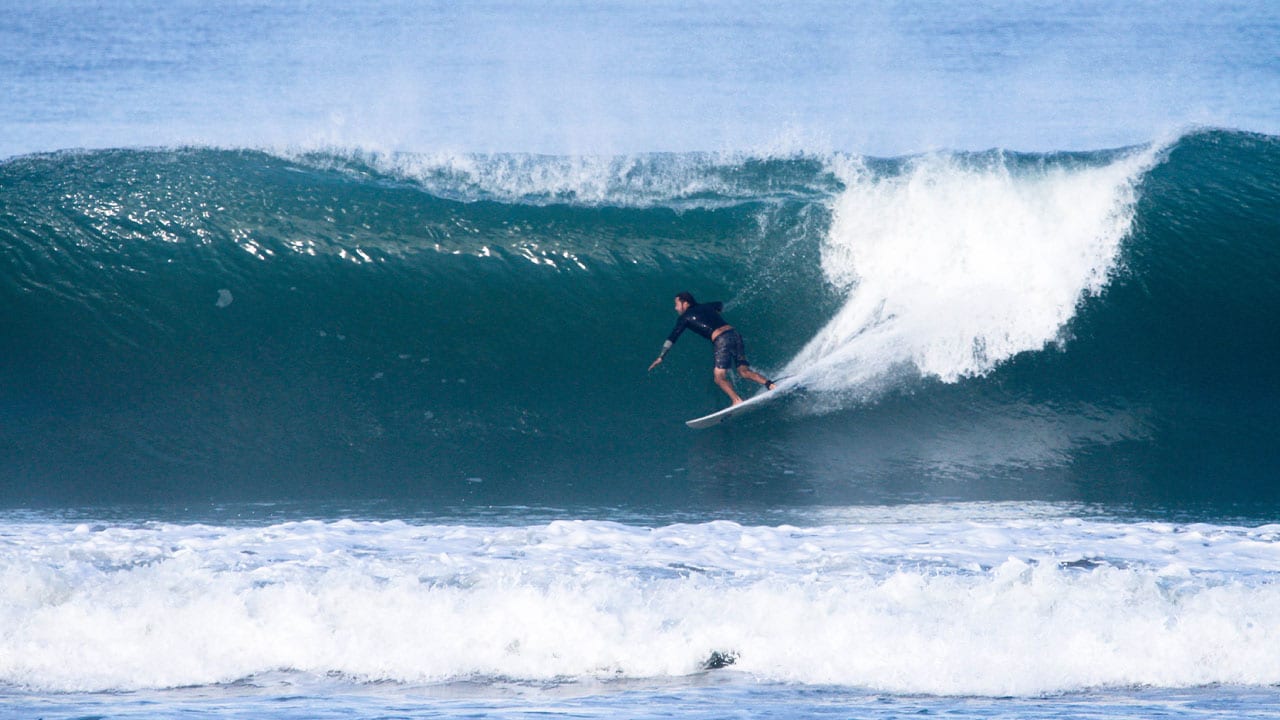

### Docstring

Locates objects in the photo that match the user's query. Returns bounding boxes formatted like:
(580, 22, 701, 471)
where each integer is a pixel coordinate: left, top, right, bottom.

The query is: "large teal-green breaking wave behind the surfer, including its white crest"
(0, 132, 1280, 511)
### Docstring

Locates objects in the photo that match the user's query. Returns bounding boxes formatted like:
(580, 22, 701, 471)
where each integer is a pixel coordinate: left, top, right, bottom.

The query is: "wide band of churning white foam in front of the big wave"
(0, 506, 1280, 694)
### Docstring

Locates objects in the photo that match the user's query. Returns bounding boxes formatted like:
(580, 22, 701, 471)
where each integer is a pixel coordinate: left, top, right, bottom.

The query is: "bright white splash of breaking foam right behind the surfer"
(782, 147, 1158, 391)
